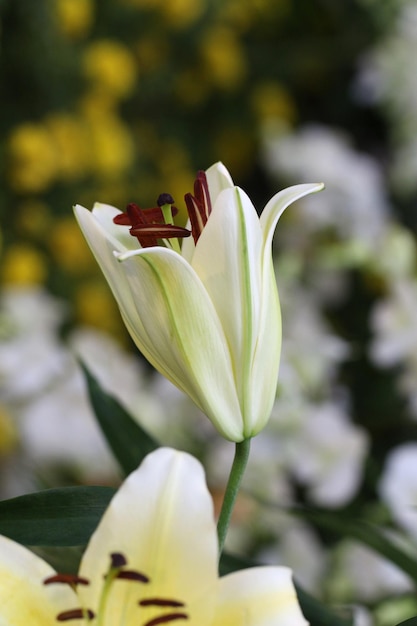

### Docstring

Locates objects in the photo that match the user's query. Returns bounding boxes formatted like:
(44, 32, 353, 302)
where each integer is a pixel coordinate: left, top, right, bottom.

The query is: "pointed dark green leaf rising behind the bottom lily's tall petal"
(81, 364, 159, 476)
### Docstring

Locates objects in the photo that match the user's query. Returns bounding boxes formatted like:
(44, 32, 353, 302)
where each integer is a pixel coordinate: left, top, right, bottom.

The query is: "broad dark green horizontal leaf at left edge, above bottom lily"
(0, 487, 116, 546)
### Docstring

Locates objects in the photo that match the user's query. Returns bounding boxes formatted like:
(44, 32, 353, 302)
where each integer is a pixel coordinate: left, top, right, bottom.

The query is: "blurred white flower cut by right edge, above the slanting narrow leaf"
(379, 442, 417, 538)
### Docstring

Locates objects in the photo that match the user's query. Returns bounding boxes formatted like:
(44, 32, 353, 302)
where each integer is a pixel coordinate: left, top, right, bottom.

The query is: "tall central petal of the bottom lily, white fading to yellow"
(79, 448, 218, 626)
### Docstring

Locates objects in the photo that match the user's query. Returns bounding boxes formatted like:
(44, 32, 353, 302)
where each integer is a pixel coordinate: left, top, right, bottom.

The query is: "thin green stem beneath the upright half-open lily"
(217, 439, 250, 557)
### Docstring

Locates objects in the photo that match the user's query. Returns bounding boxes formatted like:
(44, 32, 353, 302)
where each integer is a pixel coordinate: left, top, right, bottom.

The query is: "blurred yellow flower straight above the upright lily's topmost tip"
(201, 26, 246, 91)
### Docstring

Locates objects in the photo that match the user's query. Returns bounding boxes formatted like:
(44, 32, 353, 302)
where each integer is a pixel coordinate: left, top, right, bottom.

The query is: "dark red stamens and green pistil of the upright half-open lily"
(113, 171, 212, 252)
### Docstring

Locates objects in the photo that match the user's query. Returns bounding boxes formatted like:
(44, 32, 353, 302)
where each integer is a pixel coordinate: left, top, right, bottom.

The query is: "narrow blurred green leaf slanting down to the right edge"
(289, 507, 417, 584)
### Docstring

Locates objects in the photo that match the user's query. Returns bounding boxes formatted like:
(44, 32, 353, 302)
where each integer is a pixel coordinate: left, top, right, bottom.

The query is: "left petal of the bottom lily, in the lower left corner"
(0, 536, 79, 626)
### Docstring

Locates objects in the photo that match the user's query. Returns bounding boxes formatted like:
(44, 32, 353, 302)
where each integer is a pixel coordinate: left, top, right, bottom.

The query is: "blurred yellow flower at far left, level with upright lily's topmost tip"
(8, 122, 57, 193)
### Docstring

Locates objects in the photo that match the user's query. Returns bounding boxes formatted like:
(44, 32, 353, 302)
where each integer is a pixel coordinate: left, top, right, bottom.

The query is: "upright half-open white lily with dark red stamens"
(75, 163, 323, 442)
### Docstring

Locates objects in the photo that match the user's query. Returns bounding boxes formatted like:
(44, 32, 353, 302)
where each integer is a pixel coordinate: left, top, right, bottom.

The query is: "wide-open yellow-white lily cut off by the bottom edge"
(0, 448, 307, 626)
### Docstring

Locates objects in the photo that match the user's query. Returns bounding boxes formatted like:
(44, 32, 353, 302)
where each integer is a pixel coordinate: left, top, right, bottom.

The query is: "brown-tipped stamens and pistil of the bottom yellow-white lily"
(44, 552, 189, 626)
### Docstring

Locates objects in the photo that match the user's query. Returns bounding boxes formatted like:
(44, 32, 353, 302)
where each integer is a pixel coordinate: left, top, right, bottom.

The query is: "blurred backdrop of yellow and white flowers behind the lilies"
(0, 0, 417, 626)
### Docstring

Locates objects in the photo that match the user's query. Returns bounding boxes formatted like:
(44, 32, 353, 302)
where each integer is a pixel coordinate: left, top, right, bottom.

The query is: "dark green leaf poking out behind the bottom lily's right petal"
(220, 552, 352, 626)
